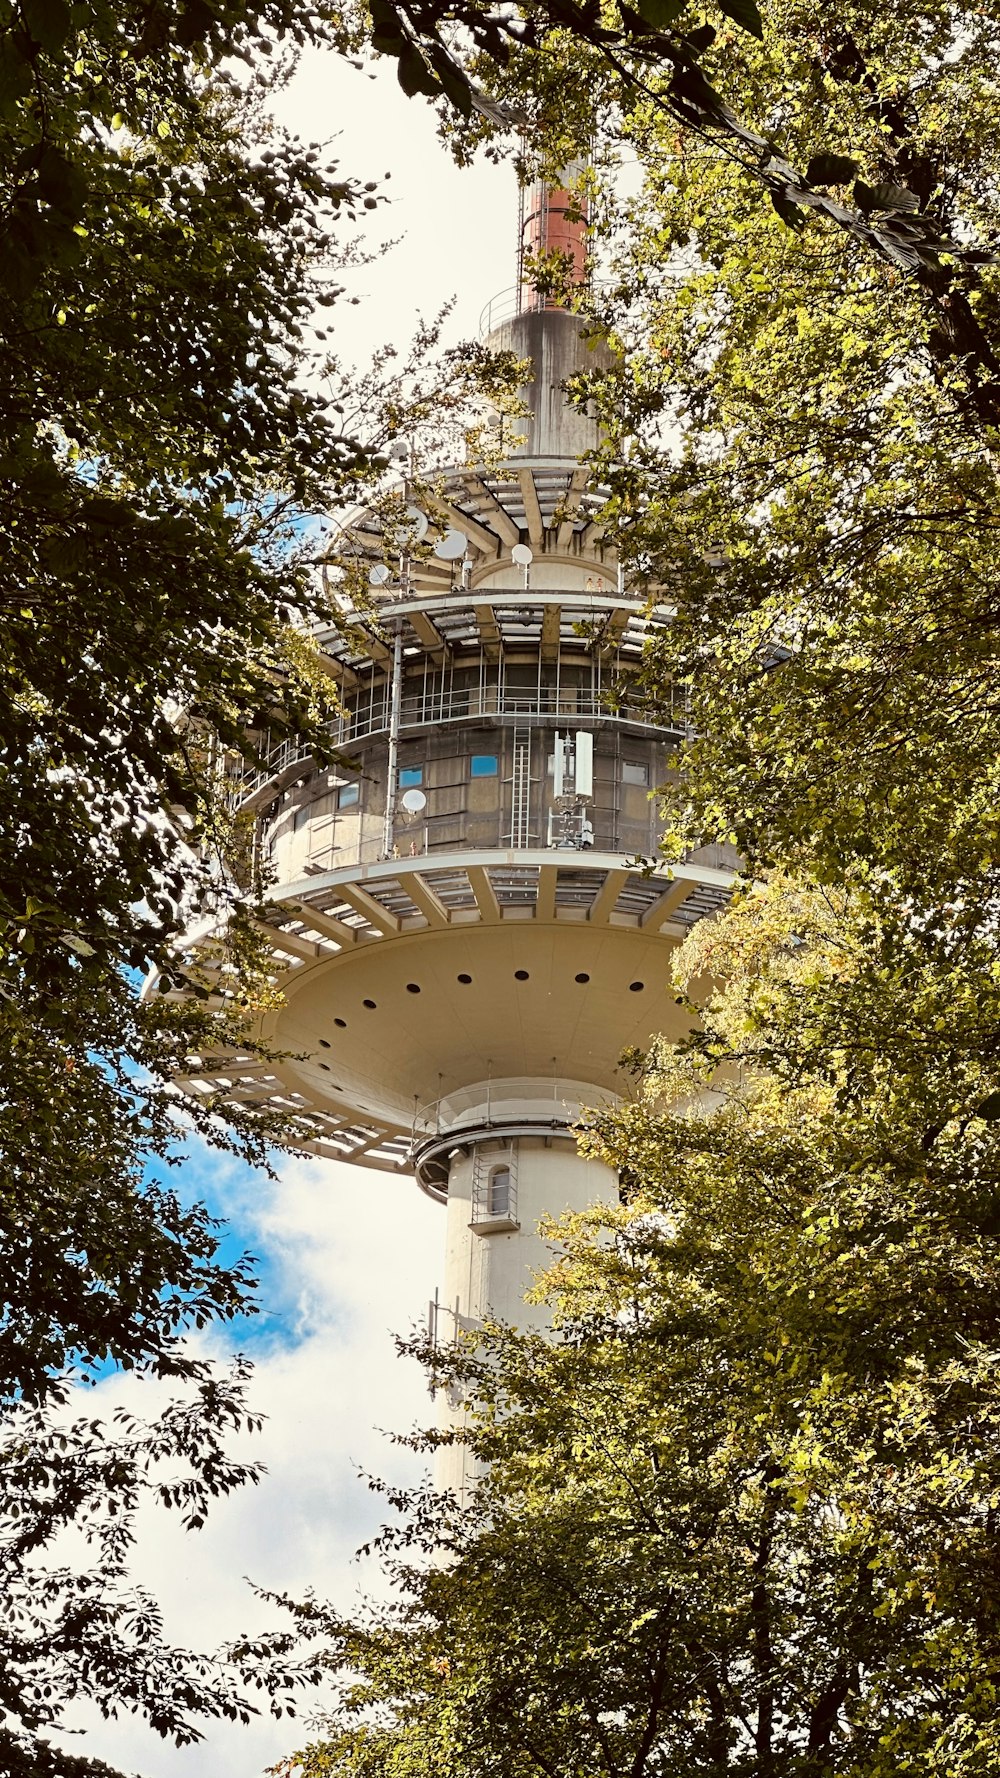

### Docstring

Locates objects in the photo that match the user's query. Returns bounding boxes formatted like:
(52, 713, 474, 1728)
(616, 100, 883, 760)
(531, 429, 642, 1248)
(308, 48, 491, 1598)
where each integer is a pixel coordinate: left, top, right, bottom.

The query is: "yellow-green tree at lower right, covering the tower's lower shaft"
(272, 885, 1000, 1778)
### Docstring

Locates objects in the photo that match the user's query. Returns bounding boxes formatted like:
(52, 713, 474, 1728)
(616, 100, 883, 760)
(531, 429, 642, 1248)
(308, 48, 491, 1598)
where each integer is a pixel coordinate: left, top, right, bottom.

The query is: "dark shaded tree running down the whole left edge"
(0, 0, 396, 1774)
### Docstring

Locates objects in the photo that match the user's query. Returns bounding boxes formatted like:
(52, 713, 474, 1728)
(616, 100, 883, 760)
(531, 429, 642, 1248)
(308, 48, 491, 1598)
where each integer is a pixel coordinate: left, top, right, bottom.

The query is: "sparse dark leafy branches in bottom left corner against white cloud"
(0, 1364, 311, 1778)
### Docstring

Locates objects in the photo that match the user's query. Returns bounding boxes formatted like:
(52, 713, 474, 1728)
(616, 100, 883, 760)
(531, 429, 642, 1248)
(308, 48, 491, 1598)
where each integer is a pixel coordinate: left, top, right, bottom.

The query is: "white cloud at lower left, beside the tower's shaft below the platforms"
(53, 1161, 443, 1778)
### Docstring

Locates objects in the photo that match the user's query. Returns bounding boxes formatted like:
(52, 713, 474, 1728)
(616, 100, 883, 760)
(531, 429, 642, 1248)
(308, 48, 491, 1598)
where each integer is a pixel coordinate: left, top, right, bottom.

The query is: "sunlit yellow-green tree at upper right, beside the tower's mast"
(516, 5, 996, 917)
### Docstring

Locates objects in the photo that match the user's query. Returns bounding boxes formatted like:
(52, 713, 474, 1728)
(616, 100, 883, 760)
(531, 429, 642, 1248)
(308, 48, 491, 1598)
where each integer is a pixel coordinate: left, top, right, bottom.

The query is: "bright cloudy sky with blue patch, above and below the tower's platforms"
(52, 41, 505, 1778)
